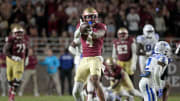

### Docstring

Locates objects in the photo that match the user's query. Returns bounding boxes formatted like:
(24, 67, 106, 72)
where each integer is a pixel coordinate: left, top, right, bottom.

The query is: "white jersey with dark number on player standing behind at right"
(136, 34, 159, 55)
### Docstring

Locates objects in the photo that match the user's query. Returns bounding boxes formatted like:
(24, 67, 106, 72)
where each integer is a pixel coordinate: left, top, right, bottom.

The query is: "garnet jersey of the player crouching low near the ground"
(103, 65, 123, 81)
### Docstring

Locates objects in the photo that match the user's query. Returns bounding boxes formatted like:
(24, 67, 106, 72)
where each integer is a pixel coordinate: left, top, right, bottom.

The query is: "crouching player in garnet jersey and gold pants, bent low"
(103, 58, 142, 101)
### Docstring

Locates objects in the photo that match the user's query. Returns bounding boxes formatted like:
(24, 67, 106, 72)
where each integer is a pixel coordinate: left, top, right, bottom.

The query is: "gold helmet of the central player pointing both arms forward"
(82, 7, 98, 23)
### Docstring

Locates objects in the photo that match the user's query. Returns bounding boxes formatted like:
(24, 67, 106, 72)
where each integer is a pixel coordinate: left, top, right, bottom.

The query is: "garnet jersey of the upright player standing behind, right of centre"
(113, 37, 133, 61)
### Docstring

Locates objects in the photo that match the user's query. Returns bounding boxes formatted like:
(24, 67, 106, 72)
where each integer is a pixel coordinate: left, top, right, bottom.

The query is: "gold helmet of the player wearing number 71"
(12, 26, 24, 38)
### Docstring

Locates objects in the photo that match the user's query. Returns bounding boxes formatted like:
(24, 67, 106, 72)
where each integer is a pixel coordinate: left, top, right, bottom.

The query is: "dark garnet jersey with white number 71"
(6, 36, 29, 58)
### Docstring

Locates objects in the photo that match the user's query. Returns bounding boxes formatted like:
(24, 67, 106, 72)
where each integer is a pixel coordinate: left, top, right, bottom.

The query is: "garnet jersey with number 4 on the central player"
(76, 23, 107, 57)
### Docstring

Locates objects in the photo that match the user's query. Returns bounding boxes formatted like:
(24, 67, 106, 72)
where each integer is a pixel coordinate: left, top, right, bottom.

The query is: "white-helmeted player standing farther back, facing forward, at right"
(136, 24, 159, 72)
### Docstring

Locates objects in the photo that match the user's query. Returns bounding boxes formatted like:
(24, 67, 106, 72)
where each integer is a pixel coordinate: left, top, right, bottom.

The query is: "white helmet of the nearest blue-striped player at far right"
(154, 41, 171, 56)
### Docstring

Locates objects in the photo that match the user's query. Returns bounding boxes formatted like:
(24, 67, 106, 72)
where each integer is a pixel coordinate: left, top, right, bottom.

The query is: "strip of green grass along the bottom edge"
(0, 96, 180, 101)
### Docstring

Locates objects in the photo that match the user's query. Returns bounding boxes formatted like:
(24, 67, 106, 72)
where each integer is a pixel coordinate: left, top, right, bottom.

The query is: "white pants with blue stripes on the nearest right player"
(139, 77, 157, 101)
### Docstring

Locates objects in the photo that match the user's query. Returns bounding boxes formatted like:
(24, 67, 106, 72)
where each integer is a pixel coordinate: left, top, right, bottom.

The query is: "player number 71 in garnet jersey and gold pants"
(3, 25, 28, 101)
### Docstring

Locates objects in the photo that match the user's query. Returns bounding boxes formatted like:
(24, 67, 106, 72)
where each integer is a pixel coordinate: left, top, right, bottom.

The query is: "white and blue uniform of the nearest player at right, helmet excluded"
(139, 54, 169, 101)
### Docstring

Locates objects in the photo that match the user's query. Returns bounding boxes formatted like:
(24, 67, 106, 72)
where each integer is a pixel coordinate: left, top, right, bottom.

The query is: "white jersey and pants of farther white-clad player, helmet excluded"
(136, 34, 159, 71)
